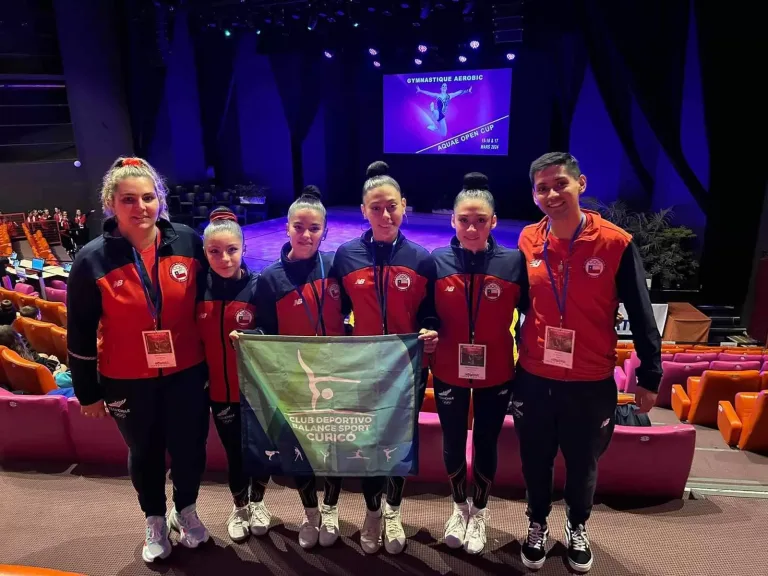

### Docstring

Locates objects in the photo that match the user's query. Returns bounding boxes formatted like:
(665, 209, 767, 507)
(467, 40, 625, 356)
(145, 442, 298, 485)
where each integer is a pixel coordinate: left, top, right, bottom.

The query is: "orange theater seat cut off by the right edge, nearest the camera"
(717, 391, 768, 452)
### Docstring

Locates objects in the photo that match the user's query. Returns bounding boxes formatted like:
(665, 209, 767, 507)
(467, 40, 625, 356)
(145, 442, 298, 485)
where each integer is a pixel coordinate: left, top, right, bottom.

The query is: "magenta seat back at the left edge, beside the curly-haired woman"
(0, 394, 75, 462)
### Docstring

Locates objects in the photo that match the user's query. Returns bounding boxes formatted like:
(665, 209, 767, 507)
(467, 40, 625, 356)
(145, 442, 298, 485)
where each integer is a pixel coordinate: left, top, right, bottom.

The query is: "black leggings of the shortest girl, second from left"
(211, 402, 269, 507)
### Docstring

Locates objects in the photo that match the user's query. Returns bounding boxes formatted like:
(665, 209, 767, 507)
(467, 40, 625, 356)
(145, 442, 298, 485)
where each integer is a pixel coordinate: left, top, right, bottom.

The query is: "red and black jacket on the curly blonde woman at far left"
(67, 218, 207, 405)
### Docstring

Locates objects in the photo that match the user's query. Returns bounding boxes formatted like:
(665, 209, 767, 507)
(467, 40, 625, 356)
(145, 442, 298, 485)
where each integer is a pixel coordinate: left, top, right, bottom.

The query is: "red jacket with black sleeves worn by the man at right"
(518, 210, 661, 391)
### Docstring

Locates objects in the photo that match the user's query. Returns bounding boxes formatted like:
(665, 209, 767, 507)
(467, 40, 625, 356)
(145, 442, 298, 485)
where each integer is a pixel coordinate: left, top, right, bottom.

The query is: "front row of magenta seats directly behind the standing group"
(0, 390, 696, 498)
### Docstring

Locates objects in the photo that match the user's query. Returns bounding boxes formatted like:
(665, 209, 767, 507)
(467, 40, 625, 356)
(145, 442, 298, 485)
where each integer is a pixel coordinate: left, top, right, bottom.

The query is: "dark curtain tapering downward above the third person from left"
(269, 50, 324, 196)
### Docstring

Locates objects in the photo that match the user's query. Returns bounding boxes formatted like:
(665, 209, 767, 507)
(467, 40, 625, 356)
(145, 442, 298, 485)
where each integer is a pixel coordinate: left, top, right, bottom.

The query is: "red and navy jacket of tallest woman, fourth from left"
(333, 230, 439, 338)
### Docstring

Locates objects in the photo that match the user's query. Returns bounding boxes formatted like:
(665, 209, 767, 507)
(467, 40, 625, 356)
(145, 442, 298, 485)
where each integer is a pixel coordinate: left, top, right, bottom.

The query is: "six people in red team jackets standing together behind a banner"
(68, 153, 661, 572)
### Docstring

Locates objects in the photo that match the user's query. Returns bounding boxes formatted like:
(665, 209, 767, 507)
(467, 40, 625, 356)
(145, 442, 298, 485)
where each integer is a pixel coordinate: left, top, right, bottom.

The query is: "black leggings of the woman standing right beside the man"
(433, 378, 512, 508)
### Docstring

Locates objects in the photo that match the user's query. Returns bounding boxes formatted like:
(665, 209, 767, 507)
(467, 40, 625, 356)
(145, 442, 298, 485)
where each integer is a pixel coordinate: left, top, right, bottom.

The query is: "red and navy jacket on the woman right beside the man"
(431, 236, 528, 388)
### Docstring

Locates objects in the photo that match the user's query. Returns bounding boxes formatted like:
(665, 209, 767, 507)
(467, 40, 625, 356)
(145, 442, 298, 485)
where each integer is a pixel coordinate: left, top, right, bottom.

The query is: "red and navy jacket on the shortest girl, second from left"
(197, 264, 258, 404)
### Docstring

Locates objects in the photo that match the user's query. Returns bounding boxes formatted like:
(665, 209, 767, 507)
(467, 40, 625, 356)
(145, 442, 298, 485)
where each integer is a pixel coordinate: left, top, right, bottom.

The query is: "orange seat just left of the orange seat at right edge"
(672, 370, 761, 426)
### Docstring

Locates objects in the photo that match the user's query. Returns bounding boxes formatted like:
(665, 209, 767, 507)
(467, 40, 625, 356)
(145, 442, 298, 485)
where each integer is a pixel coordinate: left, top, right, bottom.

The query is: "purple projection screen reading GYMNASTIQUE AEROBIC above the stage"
(384, 68, 512, 156)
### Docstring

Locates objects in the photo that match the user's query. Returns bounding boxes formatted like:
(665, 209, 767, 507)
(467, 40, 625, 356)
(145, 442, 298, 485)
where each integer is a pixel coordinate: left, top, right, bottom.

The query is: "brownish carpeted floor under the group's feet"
(0, 470, 768, 576)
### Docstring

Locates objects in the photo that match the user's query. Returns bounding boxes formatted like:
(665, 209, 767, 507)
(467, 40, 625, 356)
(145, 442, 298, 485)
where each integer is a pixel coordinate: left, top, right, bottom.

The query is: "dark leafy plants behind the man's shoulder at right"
(582, 198, 699, 288)
